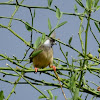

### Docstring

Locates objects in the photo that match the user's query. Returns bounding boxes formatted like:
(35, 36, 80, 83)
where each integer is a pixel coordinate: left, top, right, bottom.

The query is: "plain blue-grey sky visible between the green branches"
(0, 0, 100, 100)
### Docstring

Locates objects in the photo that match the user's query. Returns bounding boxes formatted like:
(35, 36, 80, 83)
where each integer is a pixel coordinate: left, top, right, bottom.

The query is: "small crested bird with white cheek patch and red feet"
(29, 32, 56, 72)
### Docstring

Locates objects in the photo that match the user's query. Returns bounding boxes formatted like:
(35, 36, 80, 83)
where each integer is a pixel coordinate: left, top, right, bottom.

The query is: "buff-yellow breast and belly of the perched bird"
(33, 46, 53, 68)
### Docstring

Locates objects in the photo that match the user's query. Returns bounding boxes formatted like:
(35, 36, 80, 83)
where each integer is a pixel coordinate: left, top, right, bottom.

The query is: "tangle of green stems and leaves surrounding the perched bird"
(0, 0, 100, 100)
